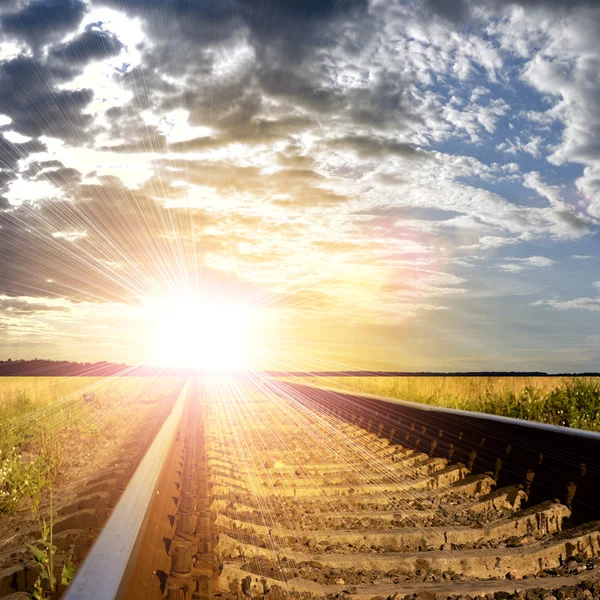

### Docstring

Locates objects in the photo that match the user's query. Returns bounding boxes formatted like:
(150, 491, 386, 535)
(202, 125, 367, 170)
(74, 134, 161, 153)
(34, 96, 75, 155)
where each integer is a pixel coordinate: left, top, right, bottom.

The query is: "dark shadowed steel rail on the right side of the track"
(270, 380, 600, 523)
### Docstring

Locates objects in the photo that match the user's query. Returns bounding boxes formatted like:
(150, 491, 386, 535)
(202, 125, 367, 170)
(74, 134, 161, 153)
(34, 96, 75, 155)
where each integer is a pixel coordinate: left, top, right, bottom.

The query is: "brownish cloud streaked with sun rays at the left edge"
(0, 181, 189, 301)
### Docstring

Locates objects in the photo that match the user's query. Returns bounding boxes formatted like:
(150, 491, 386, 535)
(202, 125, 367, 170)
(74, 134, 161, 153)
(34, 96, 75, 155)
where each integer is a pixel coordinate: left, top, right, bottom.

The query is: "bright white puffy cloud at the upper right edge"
(490, 2, 600, 218)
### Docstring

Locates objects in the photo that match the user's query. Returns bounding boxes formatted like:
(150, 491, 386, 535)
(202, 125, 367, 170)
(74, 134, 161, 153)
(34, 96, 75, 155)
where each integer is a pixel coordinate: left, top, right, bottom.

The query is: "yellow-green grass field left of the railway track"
(0, 377, 178, 514)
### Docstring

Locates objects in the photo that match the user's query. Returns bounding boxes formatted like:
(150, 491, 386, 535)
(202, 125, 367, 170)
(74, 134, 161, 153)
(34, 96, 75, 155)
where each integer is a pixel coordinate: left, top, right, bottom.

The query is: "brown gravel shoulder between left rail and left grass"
(0, 388, 183, 598)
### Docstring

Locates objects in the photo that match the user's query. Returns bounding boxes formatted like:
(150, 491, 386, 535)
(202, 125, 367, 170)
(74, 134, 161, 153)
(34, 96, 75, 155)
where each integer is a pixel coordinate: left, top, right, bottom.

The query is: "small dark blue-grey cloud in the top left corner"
(0, 0, 87, 48)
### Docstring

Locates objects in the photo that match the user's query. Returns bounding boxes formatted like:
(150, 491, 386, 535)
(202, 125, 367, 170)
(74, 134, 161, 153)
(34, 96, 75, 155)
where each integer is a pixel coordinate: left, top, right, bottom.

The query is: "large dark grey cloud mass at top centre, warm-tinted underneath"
(91, 0, 412, 173)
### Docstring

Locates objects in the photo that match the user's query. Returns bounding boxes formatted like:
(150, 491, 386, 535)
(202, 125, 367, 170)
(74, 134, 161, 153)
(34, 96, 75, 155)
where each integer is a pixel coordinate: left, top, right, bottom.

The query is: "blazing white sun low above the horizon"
(151, 298, 251, 371)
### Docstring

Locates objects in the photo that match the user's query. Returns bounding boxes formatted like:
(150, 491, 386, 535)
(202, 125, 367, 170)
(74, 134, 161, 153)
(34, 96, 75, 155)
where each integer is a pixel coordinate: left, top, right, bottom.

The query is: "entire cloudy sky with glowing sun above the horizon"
(0, 0, 600, 372)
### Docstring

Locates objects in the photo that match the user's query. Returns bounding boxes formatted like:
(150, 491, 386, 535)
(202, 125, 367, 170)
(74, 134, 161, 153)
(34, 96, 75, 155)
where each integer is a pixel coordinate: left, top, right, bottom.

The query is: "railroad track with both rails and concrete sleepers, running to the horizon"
(54, 379, 600, 600)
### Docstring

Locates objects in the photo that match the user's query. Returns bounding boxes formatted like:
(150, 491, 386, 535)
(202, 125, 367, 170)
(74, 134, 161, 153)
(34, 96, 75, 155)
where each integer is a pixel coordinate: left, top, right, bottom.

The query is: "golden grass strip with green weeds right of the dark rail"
(294, 377, 600, 431)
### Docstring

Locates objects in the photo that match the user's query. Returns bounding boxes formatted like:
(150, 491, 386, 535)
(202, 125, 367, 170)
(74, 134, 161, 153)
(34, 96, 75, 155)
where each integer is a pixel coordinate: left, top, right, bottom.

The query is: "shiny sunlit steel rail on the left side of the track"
(63, 379, 190, 600)
